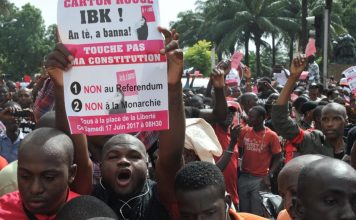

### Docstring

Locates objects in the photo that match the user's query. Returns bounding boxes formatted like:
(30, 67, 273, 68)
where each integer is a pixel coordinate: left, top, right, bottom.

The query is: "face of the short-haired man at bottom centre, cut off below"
(176, 186, 227, 220)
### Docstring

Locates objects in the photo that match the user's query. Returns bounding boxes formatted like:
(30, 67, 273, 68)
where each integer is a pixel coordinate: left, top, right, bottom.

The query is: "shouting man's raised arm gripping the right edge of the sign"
(156, 28, 185, 209)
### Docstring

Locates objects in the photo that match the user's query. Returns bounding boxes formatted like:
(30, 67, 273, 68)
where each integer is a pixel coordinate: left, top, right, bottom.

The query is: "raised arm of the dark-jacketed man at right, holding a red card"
(271, 57, 307, 140)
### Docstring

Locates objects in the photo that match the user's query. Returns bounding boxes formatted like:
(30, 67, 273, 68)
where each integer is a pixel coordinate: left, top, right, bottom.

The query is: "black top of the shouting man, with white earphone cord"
(92, 180, 170, 220)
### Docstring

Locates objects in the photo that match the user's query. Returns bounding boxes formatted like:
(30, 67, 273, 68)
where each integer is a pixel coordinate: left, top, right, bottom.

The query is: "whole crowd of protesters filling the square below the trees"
(0, 28, 356, 220)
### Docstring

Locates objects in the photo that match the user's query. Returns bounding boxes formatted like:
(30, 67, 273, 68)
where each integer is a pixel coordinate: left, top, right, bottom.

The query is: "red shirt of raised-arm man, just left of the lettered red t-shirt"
(213, 124, 239, 204)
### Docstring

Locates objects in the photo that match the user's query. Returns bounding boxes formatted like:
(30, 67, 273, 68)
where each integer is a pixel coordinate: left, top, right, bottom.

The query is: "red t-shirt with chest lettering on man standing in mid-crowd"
(238, 127, 282, 176)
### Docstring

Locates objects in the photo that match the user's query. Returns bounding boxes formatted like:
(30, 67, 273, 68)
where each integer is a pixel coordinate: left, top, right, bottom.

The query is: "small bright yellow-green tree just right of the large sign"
(184, 40, 212, 76)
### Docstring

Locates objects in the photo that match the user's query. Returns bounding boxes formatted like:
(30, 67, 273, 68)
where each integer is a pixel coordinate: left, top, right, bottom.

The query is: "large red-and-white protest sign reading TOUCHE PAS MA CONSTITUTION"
(57, 0, 169, 135)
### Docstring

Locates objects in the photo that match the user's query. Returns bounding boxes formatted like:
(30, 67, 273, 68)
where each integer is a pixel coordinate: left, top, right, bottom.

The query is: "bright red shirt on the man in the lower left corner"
(0, 191, 80, 220)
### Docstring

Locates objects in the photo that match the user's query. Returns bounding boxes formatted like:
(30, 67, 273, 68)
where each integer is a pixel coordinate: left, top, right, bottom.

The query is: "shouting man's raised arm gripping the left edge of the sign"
(46, 44, 93, 194)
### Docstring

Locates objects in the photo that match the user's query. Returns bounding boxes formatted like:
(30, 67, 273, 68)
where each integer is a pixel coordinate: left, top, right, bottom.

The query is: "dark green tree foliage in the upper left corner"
(0, 4, 54, 80)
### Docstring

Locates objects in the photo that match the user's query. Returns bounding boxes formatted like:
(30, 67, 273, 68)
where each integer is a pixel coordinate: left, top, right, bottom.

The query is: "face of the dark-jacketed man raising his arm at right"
(321, 107, 346, 139)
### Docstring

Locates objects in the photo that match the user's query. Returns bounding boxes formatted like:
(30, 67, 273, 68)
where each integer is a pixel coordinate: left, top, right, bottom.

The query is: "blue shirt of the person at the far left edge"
(0, 133, 22, 163)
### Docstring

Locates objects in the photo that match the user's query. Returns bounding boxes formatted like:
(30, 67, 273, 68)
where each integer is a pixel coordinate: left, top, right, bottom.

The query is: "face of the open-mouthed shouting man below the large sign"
(101, 144, 147, 199)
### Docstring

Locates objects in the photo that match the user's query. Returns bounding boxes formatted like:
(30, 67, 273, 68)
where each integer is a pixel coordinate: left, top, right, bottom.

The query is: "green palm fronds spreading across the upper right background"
(173, 0, 350, 75)
